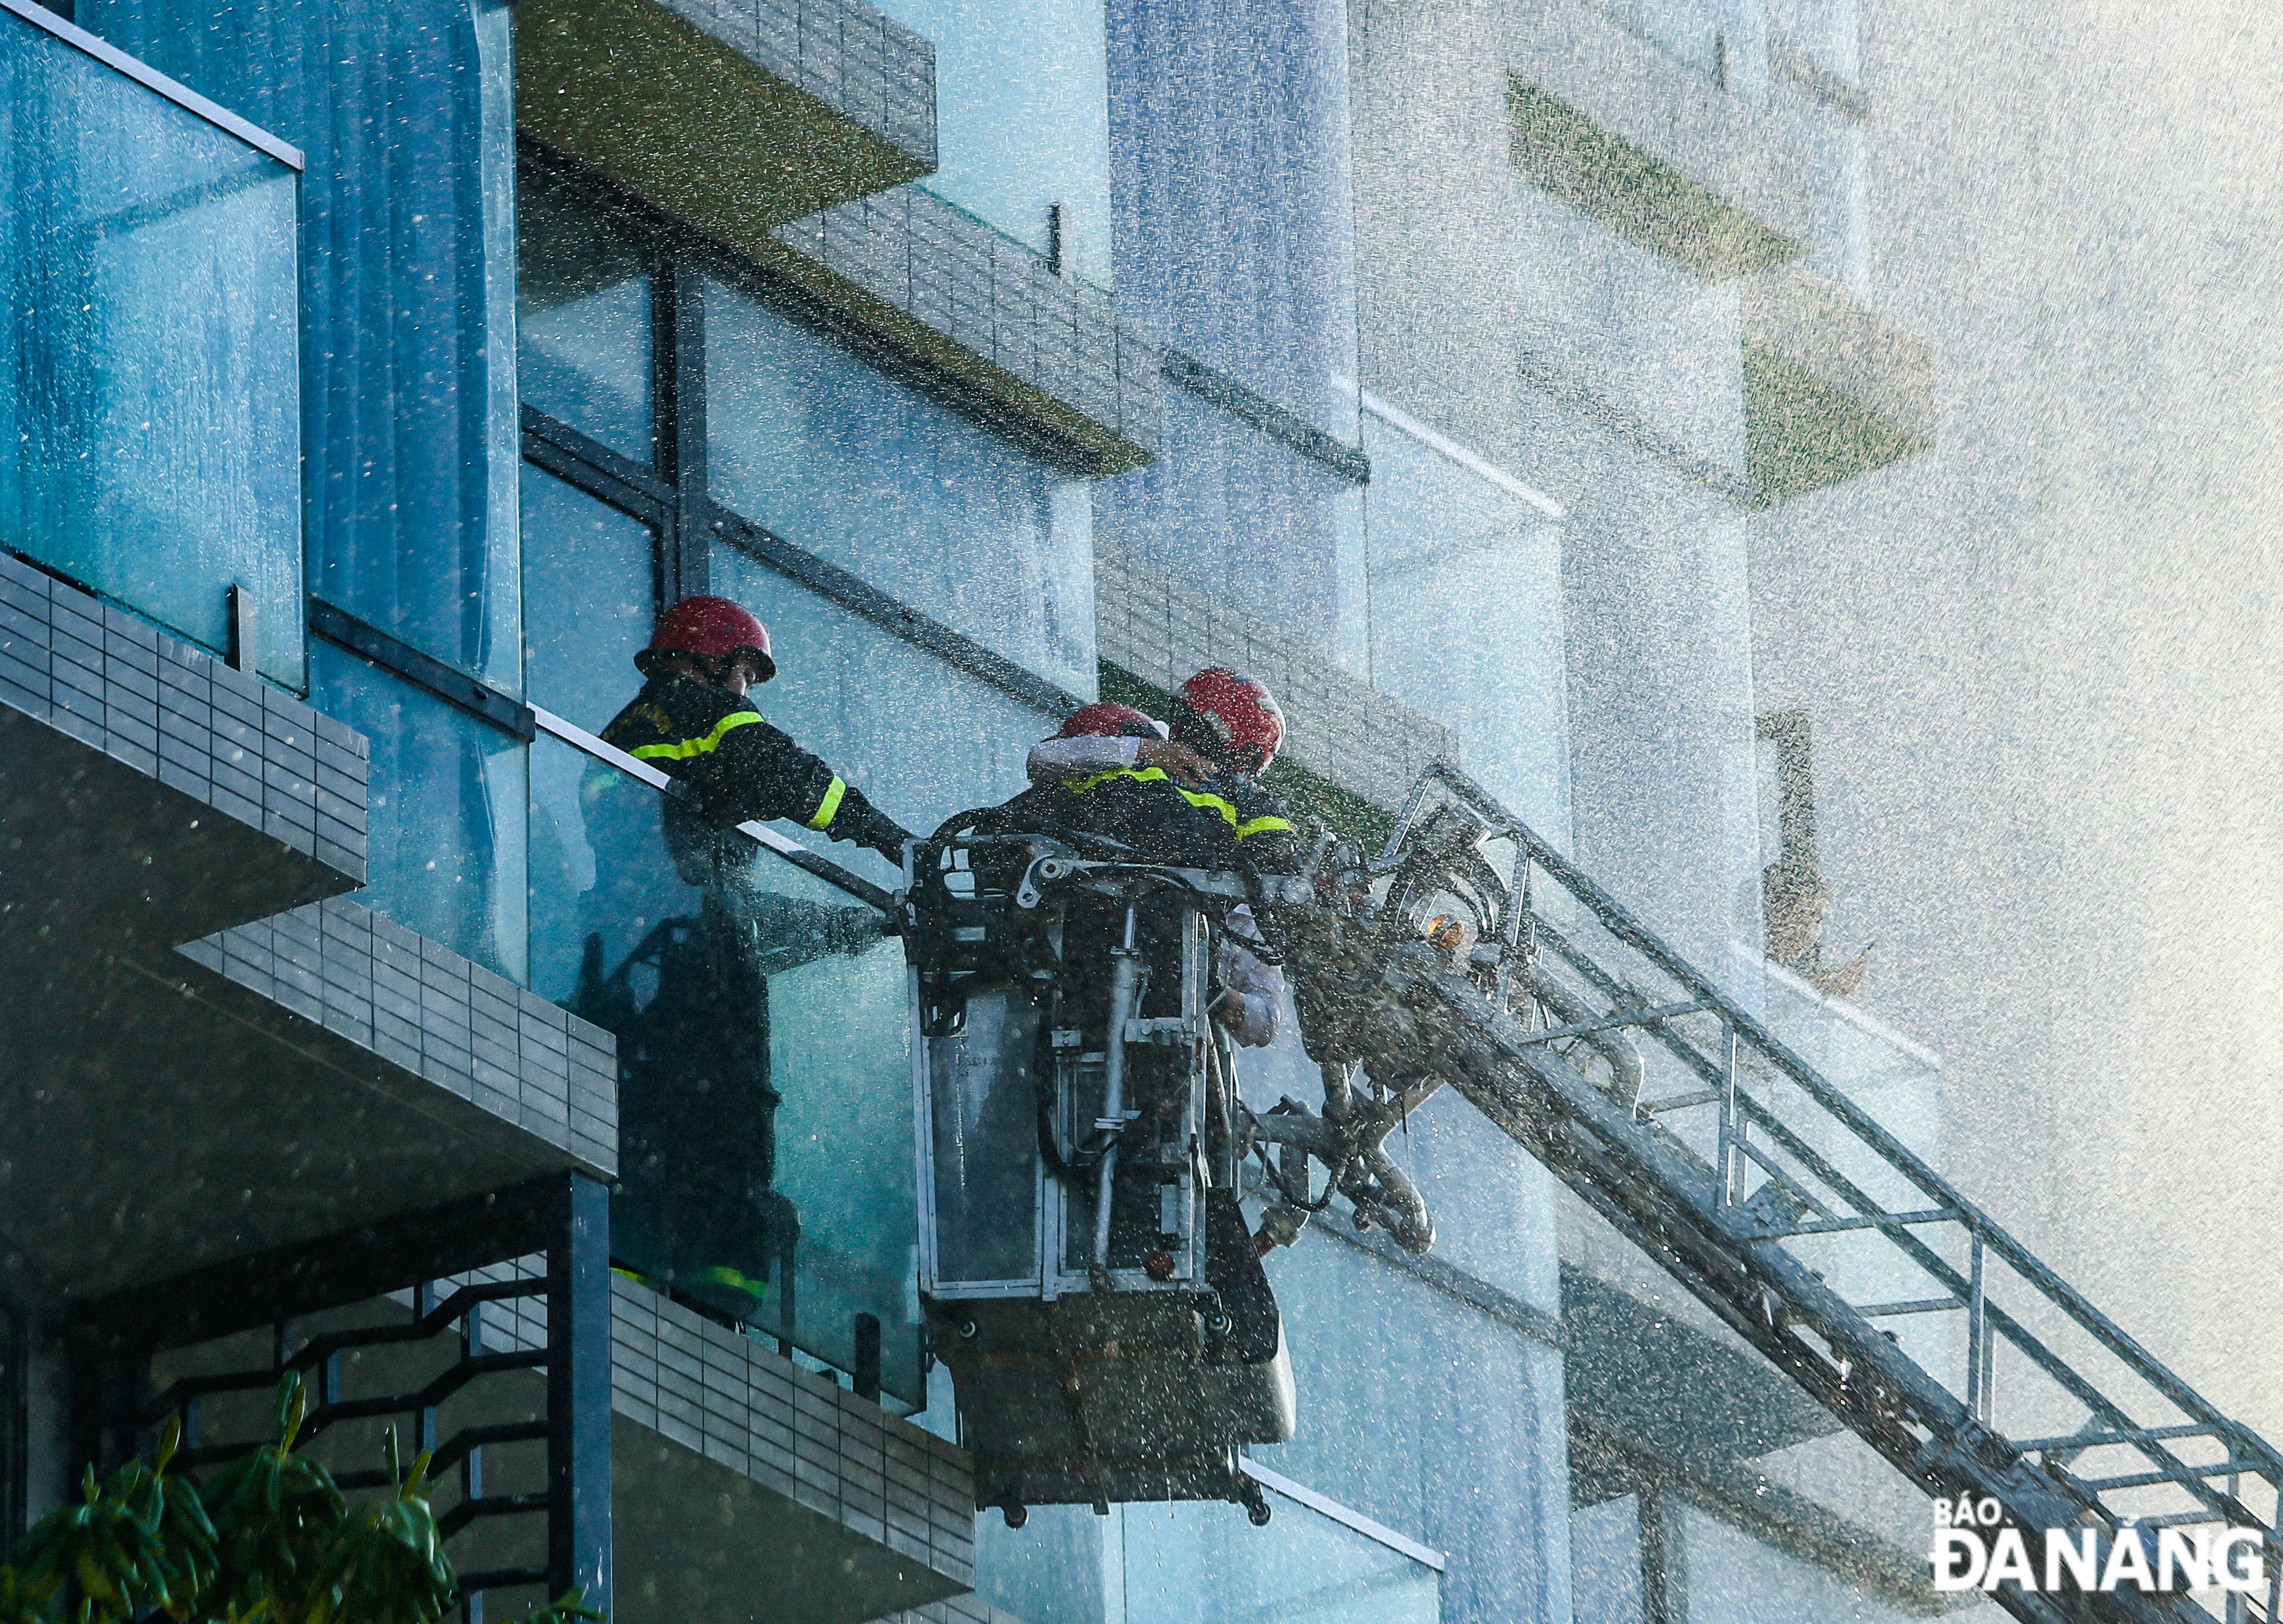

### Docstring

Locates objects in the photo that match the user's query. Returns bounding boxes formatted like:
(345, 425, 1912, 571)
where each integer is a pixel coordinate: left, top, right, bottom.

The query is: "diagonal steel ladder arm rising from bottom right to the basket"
(1253, 765, 2283, 1624)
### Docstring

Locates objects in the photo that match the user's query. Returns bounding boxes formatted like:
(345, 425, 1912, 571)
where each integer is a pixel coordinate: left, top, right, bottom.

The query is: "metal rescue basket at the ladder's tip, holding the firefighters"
(904, 813, 1297, 1526)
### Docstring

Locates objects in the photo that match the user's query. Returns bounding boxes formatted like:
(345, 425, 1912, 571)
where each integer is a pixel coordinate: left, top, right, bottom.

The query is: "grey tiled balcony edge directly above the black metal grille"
(178, 898, 618, 1174)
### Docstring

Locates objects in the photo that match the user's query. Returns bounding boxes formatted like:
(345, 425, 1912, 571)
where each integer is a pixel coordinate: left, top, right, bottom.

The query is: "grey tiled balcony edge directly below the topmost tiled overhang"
(774, 185, 1160, 454)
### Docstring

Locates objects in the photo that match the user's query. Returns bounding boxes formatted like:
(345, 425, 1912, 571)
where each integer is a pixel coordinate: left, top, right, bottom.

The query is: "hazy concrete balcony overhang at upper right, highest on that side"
(1507, 0, 1813, 281)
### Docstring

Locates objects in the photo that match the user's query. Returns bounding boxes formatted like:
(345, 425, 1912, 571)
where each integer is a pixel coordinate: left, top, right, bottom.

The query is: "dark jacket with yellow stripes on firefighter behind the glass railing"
(603, 676, 906, 861)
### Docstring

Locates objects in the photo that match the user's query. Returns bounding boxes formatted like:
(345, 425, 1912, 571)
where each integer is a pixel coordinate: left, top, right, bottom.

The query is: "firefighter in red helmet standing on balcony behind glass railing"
(580, 599, 906, 1331)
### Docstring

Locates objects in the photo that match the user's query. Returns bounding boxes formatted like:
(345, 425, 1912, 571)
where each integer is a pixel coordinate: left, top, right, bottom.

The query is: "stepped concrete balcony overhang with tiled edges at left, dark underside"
(0, 566, 616, 1298)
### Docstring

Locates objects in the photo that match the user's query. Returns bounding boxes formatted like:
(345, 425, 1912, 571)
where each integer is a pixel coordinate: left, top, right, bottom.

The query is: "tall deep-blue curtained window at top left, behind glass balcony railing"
(75, 0, 523, 692)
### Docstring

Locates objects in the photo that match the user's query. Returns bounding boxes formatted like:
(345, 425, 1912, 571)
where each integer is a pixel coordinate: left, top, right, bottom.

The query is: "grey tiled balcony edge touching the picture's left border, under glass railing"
(0, 553, 367, 884)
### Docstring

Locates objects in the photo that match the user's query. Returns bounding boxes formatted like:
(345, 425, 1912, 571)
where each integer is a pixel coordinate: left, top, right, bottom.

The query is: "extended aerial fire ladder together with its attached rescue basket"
(902, 765, 2283, 1624)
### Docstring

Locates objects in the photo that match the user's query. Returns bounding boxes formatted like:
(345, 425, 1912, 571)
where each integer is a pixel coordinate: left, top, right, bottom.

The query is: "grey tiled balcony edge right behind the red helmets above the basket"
(1093, 541, 1459, 811)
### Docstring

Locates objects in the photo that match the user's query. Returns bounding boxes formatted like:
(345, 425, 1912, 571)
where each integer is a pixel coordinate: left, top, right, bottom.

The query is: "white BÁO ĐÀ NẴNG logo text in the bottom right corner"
(1931, 1494, 2267, 1592)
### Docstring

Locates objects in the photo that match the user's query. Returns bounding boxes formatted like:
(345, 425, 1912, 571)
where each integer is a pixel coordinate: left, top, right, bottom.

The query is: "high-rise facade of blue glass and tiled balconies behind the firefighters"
(0, 0, 2264, 1624)
